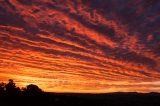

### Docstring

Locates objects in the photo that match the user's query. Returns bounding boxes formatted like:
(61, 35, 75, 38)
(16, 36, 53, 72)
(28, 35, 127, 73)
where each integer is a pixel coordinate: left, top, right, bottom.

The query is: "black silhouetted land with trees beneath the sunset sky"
(0, 80, 160, 106)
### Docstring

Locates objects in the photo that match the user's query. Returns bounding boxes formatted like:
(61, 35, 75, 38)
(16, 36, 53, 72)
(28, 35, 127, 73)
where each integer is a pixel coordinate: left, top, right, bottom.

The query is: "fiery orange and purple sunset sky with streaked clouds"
(0, 0, 160, 93)
